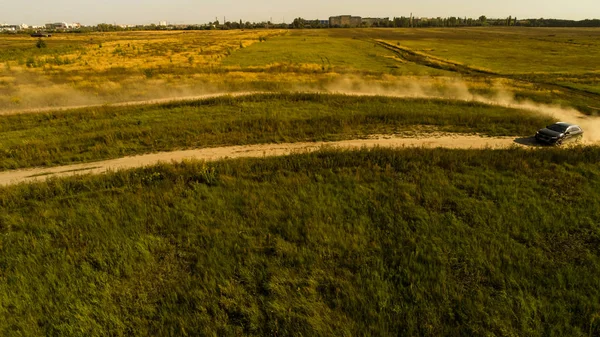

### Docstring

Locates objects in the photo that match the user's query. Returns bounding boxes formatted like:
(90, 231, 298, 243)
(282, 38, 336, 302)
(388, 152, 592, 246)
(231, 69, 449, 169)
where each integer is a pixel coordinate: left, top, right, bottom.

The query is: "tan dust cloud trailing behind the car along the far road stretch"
(0, 71, 600, 143)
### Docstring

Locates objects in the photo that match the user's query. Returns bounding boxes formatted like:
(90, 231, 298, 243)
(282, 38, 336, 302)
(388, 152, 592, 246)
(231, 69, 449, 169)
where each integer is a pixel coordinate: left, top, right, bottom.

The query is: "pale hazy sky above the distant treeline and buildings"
(0, 0, 600, 25)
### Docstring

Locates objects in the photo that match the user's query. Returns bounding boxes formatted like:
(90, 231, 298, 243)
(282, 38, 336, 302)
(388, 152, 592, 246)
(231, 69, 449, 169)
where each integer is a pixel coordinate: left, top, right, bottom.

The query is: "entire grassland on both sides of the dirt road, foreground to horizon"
(0, 27, 600, 337)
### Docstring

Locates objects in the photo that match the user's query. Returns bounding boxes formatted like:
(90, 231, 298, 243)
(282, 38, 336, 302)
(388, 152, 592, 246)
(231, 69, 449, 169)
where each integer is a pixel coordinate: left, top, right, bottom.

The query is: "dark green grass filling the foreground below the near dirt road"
(0, 148, 600, 336)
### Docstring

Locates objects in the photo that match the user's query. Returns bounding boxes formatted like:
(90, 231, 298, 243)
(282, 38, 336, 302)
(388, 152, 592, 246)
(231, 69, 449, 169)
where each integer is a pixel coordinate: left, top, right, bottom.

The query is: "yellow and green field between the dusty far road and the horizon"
(0, 28, 600, 114)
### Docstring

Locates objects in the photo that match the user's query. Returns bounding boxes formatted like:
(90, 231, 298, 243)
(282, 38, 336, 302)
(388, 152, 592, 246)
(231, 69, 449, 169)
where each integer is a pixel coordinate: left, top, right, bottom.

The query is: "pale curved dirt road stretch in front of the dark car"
(0, 134, 529, 186)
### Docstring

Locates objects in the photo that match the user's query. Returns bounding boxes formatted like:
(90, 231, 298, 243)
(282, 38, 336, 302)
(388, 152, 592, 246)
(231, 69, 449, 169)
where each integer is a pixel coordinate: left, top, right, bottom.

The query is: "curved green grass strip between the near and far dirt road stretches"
(0, 94, 552, 169)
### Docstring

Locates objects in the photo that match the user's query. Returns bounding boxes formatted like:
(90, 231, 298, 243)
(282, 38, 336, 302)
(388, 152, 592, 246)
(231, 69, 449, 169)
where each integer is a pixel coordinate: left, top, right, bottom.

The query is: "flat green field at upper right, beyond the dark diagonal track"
(337, 27, 600, 74)
